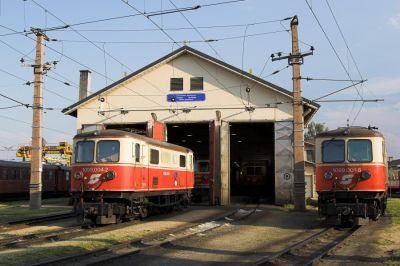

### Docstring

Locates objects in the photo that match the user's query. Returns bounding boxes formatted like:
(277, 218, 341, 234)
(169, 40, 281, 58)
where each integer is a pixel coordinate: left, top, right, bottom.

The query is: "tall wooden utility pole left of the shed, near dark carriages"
(29, 29, 47, 209)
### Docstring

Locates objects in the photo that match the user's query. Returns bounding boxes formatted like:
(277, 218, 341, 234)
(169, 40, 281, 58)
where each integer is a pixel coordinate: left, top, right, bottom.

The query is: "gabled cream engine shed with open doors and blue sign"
(63, 46, 319, 205)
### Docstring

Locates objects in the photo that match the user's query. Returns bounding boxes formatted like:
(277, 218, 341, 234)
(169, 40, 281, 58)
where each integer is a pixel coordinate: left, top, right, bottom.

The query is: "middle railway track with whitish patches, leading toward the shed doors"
(32, 208, 256, 266)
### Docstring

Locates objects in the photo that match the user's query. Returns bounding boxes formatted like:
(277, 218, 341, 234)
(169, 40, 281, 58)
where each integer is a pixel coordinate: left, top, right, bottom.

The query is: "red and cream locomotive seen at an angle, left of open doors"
(71, 130, 194, 224)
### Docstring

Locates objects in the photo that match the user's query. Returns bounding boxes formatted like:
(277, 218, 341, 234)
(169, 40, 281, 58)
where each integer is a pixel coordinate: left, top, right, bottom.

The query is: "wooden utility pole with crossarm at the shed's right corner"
(271, 16, 314, 211)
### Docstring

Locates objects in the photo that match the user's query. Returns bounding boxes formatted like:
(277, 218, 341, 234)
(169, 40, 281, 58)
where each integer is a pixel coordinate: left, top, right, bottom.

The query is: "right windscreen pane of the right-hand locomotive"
(347, 139, 372, 162)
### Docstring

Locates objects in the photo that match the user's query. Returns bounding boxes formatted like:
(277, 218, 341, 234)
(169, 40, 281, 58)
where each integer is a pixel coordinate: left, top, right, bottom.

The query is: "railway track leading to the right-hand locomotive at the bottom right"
(254, 226, 360, 266)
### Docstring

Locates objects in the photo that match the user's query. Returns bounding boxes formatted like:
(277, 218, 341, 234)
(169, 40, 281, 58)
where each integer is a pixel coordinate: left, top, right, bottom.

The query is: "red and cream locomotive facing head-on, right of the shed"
(315, 127, 388, 225)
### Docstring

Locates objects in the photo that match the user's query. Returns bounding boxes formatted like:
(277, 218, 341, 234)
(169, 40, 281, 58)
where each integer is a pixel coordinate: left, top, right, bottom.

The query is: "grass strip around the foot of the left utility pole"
(0, 198, 71, 223)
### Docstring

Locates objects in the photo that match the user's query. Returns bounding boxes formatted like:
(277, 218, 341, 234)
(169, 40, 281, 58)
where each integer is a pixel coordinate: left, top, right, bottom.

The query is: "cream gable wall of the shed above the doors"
(77, 54, 292, 129)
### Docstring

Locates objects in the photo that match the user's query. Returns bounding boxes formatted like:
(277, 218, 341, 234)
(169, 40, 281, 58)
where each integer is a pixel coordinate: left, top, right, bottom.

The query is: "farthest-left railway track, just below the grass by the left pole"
(0, 212, 76, 233)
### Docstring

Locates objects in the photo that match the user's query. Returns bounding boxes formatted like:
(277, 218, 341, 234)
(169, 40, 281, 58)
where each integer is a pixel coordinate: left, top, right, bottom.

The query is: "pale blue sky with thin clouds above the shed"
(0, 0, 400, 160)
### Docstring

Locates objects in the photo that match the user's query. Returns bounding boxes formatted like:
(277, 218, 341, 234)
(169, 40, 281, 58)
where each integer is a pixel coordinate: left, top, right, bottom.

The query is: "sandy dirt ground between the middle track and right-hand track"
(98, 205, 321, 265)
